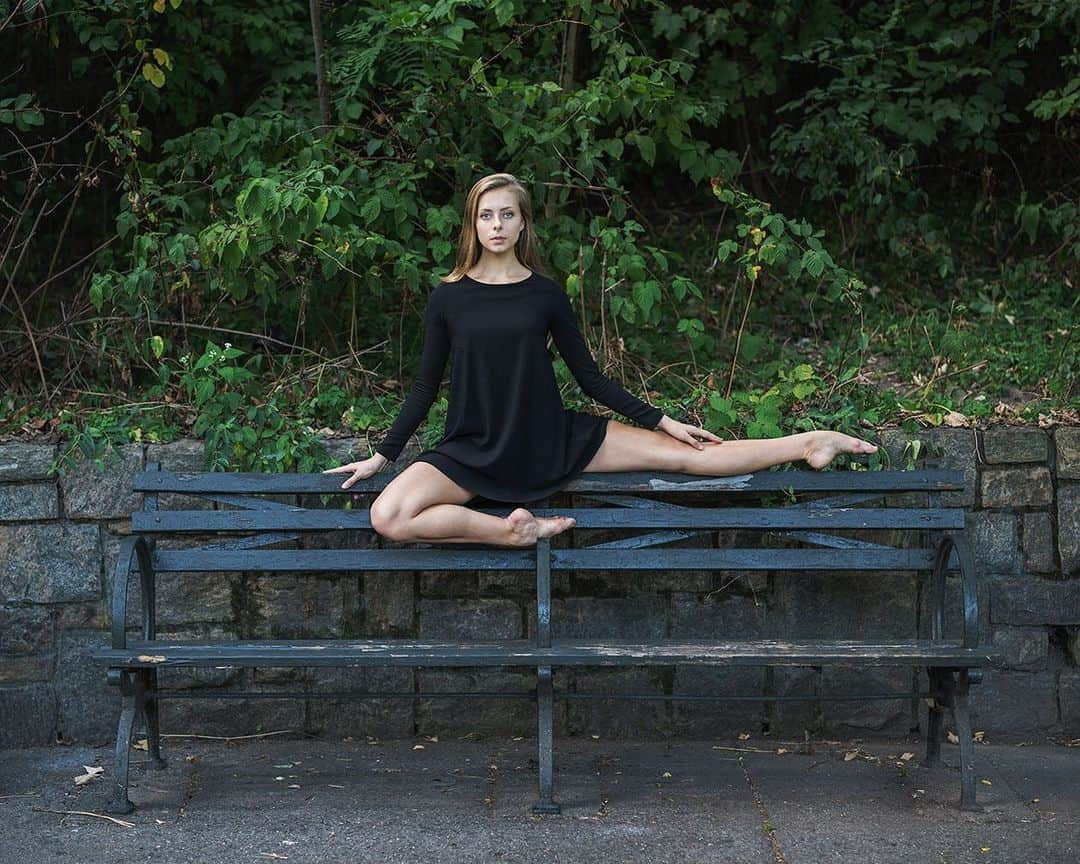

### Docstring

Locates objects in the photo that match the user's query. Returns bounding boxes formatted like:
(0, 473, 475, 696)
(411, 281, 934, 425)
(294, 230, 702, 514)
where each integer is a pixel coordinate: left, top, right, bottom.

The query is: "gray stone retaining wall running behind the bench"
(0, 427, 1080, 747)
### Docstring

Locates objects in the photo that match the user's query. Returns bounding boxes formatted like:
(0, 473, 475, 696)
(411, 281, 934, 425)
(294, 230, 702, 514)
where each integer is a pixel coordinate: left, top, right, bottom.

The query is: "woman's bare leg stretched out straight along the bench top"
(585, 419, 877, 477)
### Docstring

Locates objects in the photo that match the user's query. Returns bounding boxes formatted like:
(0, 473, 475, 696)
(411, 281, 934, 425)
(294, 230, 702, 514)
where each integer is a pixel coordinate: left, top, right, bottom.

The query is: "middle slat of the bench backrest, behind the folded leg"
(132, 508, 964, 534)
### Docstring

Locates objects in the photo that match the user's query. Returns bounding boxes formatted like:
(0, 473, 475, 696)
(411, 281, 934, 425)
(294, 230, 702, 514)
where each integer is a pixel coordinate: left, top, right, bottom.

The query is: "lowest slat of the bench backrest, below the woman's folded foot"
(147, 548, 934, 572)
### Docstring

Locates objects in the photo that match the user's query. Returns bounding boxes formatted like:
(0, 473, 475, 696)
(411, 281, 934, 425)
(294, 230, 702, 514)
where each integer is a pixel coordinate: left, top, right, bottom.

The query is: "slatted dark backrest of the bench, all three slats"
(132, 463, 964, 572)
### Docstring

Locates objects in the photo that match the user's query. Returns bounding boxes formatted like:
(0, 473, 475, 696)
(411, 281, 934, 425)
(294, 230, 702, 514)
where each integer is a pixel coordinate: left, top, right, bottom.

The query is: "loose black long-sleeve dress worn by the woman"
(375, 266, 663, 502)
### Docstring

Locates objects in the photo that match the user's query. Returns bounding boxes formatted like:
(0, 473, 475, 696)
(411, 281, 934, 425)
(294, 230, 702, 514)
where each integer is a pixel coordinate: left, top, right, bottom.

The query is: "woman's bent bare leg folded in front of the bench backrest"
(370, 462, 575, 546)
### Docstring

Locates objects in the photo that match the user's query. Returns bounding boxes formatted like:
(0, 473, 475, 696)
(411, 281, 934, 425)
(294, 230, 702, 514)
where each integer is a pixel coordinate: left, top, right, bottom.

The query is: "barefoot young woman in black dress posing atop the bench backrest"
(323, 174, 877, 546)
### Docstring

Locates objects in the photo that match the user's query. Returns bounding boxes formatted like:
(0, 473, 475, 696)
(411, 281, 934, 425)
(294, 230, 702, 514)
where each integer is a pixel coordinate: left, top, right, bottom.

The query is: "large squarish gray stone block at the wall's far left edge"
(0, 523, 102, 603)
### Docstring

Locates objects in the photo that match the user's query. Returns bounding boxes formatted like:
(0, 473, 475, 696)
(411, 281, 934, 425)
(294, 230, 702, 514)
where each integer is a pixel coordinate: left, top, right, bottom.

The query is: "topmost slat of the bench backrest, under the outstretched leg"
(133, 470, 963, 495)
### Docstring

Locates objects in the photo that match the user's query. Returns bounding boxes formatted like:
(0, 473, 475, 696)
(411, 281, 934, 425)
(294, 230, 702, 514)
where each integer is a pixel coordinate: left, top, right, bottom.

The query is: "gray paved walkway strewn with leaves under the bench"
(0, 737, 1080, 864)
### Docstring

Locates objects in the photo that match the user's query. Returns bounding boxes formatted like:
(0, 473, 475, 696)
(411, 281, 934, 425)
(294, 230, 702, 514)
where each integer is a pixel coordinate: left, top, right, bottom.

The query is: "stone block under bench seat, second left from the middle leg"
(308, 666, 414, 739)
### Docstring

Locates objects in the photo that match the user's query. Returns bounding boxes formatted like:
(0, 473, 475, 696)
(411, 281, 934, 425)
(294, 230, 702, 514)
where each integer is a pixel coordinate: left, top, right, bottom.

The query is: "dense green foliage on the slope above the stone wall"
(0, 0, 1080, 470)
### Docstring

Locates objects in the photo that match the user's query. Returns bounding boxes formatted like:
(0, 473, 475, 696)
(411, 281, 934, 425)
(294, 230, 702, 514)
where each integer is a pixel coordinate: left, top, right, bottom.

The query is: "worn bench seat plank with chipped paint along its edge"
(94, 639, 993, 669)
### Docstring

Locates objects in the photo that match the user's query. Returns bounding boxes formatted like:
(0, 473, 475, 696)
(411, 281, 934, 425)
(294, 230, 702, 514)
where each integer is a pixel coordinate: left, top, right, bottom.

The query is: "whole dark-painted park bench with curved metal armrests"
(95, 463, 993, 813)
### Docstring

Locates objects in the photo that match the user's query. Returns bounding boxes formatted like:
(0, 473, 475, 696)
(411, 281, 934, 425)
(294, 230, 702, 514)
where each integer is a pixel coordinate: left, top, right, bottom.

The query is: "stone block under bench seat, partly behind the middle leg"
(416, 667, 540, 738)
